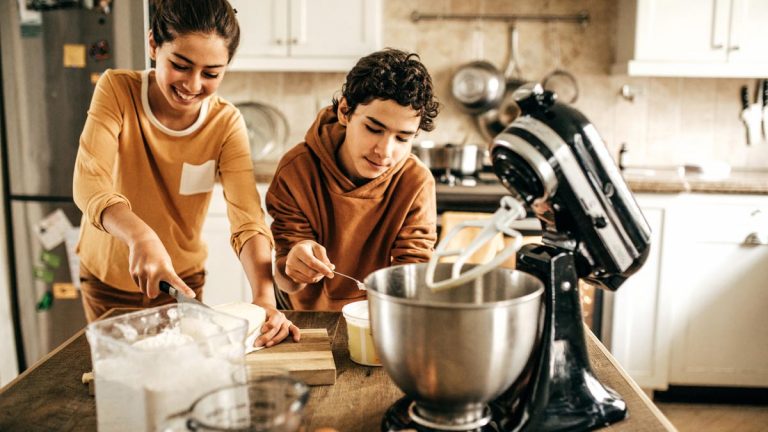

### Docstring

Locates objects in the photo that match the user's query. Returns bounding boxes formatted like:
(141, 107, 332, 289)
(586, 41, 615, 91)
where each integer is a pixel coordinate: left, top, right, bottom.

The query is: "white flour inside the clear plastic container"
(93, 317, 242, 431)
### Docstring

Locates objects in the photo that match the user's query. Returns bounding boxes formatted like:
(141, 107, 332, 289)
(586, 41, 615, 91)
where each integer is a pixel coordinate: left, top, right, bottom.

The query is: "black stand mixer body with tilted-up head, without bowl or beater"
(491, 84, 650, 431)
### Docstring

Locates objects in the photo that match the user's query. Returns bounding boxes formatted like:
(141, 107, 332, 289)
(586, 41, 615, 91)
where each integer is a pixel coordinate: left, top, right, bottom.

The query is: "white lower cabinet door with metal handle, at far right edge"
(662, 196, 768, 387)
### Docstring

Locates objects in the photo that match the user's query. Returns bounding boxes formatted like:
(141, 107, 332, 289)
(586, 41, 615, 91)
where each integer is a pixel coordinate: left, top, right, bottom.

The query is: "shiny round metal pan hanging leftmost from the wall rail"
(451, 22, 504, 114)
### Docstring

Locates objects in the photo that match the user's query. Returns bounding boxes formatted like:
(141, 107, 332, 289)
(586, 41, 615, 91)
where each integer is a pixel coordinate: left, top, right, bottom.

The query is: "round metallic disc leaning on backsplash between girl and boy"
(236, 102, 289, 162)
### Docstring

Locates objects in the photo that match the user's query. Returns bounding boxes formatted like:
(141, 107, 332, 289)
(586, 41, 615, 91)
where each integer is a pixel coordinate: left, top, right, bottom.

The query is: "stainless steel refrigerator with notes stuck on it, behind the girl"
(0, 0, 146, 371)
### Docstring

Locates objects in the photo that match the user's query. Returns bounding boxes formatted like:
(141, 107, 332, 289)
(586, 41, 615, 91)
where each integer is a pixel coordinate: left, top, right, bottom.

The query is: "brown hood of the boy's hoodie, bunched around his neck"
(304, 106, 410, 198)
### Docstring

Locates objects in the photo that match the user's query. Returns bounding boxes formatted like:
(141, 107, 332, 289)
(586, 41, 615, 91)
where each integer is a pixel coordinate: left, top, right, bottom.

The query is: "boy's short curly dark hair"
(333, 48, 440, 132)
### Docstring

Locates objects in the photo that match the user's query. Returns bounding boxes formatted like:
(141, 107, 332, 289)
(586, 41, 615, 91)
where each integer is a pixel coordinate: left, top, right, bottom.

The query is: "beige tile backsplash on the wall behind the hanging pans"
(219, 0, 768, 169)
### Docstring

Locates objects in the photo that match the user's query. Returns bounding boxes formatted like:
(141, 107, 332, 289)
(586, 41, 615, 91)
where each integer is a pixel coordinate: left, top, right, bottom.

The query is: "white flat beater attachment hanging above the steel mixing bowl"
(426, 196, 526, 291)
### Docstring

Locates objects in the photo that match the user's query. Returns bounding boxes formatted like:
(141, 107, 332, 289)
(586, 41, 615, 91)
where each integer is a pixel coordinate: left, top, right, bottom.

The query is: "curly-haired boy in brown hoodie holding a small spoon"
(266, 49, 438, 310)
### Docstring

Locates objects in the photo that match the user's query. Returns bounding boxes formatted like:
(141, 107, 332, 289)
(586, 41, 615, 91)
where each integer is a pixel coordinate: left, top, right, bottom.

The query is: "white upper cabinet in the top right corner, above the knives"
(613, 0, 768, 77)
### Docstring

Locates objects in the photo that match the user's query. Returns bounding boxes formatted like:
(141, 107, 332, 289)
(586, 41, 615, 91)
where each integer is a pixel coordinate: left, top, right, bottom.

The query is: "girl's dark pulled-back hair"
(152, 0, 240, 60)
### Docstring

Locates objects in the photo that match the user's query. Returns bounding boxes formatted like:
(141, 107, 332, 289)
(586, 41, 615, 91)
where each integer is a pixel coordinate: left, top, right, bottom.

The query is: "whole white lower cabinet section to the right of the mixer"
(607, 194, 768, 390)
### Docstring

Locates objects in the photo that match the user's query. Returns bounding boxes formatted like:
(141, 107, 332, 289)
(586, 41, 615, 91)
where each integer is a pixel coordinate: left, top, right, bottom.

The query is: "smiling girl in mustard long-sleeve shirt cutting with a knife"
(73, 0, 299, 346)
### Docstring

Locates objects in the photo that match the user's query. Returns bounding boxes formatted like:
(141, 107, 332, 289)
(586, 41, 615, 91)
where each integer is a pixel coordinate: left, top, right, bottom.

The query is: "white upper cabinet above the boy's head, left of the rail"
(230, 0, 381, 72)
